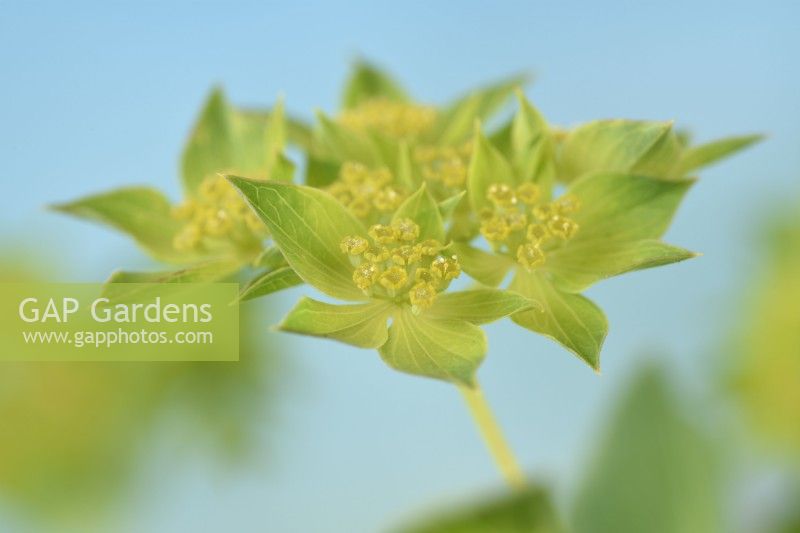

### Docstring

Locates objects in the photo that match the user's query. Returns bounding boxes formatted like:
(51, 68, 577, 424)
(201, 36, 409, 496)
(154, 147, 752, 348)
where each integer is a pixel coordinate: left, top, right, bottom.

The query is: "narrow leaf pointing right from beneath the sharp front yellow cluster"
(424, 289, 541, 325)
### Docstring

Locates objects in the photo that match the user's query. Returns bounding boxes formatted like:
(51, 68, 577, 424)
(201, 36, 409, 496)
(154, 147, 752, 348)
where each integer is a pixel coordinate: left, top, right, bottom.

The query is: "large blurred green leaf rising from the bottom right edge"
(572, 368, 721, 533)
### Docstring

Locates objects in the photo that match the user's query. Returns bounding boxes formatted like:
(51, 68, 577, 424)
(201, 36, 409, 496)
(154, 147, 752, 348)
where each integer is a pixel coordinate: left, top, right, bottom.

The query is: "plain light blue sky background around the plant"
(0, 1, 800, 532)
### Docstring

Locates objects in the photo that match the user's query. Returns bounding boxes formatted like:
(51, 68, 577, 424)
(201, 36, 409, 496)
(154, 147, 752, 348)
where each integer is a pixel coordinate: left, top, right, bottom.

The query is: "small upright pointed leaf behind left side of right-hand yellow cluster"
(467, 127, 517, 213)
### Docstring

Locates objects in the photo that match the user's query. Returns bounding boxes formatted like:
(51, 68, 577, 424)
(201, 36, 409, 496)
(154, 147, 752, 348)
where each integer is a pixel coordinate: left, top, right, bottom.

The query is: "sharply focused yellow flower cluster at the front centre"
(340, 219, 461, 312)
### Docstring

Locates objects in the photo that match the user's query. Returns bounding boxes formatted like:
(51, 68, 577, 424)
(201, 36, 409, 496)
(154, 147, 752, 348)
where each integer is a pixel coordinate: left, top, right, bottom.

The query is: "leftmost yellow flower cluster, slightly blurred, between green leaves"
(172, 176, 267, 251)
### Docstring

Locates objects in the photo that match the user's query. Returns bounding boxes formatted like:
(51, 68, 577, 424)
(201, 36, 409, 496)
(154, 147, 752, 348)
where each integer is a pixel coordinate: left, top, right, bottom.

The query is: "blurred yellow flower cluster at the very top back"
(339, 98, 436, 139)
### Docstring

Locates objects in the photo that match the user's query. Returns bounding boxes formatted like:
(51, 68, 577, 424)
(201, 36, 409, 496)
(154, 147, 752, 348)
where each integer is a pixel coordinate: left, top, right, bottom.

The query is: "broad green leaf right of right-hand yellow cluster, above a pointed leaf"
(565, 173, 694, 242)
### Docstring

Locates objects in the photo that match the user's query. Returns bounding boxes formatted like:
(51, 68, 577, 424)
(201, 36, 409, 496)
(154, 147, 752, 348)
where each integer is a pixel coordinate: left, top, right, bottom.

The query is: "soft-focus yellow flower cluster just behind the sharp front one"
(328, 162, 405, 220)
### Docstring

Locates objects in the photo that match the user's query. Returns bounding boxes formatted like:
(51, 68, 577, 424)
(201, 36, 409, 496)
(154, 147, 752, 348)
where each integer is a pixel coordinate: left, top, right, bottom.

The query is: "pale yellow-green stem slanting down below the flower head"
(458, 384, 525, 489)
